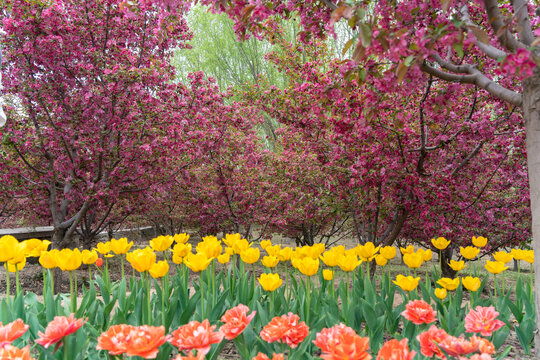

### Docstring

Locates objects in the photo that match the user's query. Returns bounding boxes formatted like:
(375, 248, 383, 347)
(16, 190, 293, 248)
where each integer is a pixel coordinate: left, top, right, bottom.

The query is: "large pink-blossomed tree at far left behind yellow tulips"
(0, 0, 191, 247)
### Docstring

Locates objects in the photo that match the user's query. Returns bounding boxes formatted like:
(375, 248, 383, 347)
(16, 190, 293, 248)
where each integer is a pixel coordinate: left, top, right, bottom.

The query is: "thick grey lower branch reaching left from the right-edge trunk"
(420, 57, 523, 106)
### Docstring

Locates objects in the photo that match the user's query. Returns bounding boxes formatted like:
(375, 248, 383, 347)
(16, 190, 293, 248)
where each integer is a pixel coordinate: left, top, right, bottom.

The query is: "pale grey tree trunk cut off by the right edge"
(523, 74, 540, 360)
